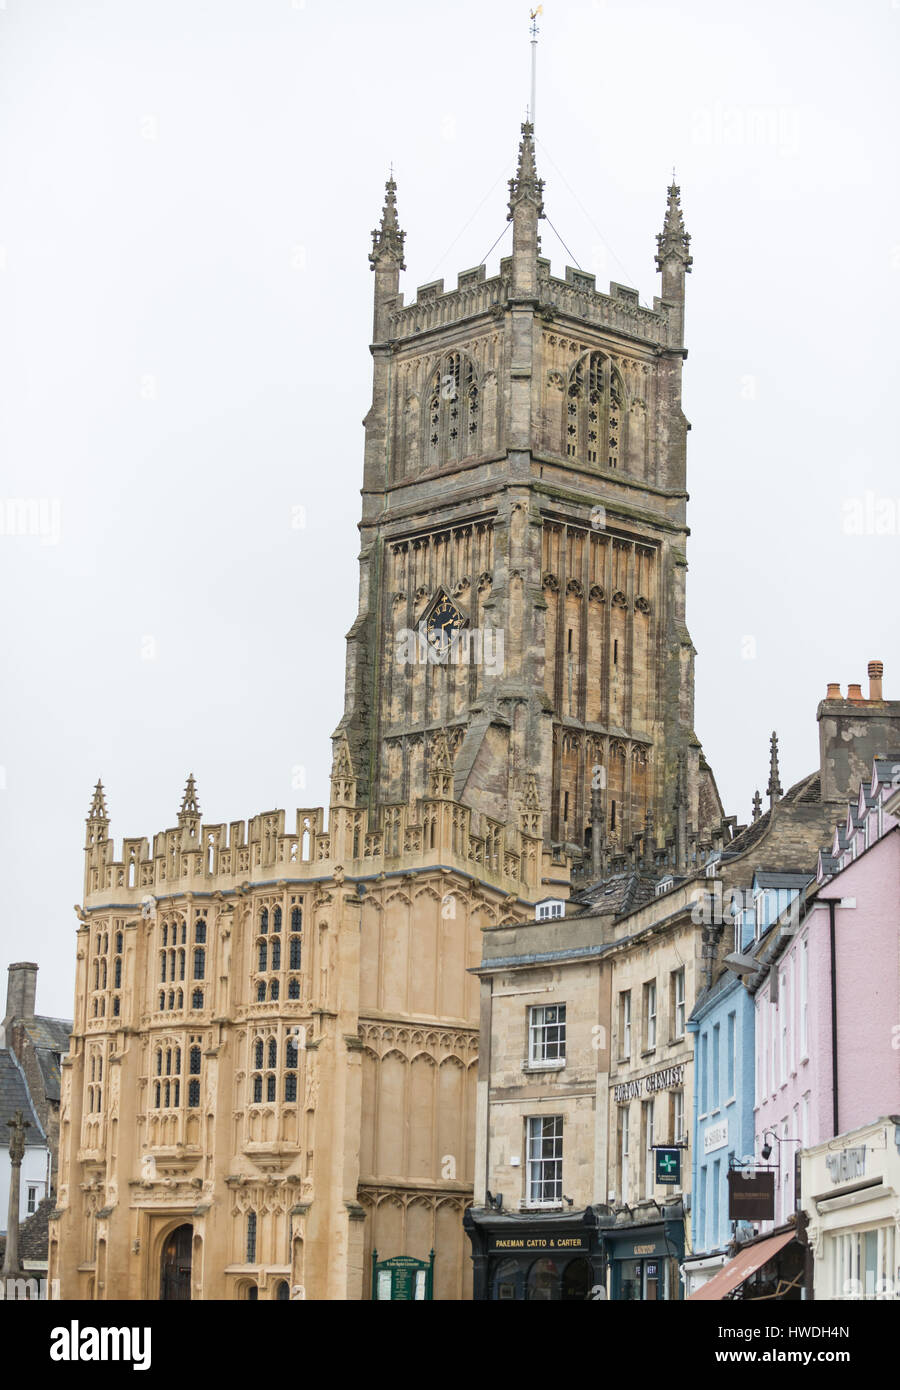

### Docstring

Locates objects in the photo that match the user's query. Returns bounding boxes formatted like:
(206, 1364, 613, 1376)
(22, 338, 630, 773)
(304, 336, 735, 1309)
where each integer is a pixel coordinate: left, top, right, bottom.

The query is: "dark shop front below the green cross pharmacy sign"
(604, 1201, 684, 1302)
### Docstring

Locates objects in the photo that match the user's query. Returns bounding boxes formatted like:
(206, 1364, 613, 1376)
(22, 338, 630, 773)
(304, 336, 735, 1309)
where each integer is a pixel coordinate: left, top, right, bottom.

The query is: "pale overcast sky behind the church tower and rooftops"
(0, 0, 900, 1015)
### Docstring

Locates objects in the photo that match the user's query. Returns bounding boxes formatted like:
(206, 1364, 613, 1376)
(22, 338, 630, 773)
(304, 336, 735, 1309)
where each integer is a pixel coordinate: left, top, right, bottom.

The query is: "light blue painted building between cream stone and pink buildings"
(682, 873, 808, 1297)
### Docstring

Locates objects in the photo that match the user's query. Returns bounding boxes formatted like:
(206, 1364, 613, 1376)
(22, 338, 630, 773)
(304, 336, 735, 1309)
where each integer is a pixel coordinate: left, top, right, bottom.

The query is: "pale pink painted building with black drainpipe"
(750, 755, 900, 1225)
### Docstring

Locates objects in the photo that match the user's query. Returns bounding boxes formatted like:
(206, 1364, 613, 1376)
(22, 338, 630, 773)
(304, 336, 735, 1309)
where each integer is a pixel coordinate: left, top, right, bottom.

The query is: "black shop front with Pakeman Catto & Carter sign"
(463, 1207, 612, 1302)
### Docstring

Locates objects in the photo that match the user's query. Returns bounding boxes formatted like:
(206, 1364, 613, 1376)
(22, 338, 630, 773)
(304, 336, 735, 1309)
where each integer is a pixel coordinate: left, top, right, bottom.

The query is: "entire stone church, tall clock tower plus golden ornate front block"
(50, 125, 721, 1300)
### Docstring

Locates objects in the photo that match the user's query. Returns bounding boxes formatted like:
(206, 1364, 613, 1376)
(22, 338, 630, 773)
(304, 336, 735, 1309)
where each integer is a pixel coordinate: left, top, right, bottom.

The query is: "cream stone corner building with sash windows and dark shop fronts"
(466, 872, 704, 1301)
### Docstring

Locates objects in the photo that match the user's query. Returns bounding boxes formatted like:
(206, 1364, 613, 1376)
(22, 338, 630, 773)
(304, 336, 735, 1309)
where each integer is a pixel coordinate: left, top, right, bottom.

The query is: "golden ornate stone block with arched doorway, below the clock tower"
(50, 756, 565, 1298)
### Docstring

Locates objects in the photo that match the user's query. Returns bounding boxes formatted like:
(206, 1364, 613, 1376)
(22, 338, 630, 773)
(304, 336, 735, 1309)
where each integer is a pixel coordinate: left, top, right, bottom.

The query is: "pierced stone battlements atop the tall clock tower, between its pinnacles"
(388, 256, 677, 348)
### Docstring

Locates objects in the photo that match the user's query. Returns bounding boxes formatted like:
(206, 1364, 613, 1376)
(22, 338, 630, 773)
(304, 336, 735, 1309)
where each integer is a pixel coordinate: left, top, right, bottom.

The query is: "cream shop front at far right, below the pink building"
(800, 1115, 900, 1300)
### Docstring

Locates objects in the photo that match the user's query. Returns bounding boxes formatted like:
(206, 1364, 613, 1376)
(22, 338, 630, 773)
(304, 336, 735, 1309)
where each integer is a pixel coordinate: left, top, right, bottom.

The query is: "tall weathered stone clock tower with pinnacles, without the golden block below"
(335, 124, 722, 877)
